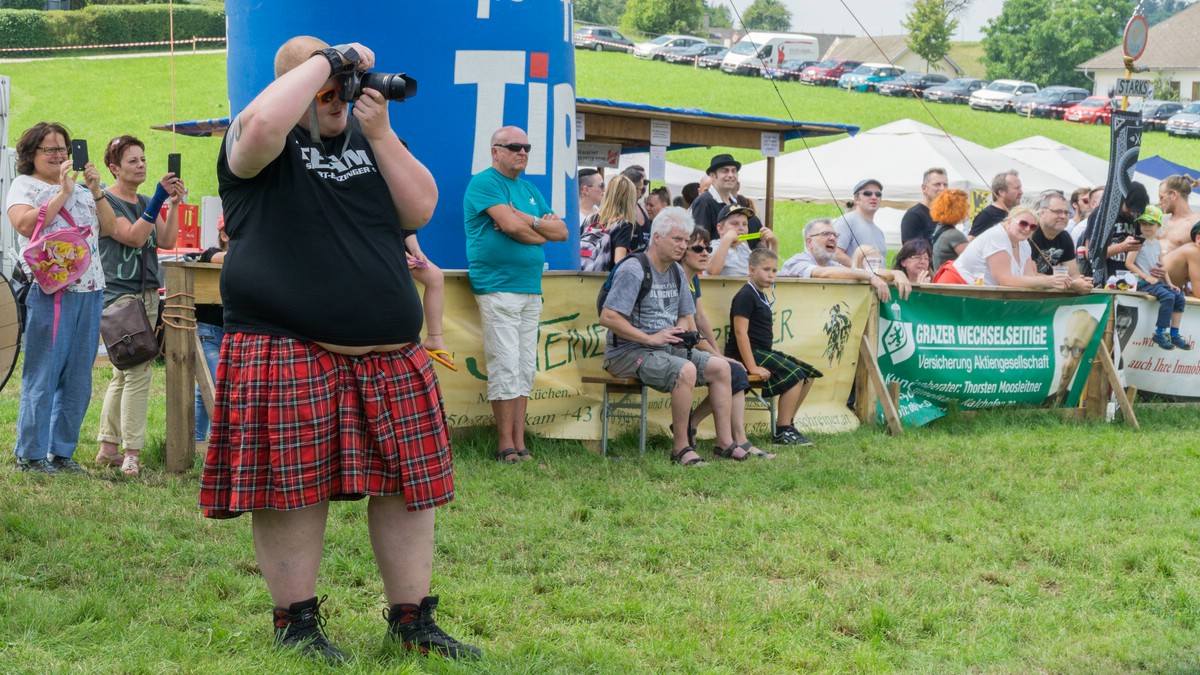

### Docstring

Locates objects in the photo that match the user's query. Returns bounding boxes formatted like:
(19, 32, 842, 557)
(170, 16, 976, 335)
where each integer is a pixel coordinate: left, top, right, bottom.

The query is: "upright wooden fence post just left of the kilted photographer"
(163, 263, 195, 473)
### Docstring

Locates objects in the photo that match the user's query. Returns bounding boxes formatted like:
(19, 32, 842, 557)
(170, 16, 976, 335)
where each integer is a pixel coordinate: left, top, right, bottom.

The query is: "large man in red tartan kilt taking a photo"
(199, 37, 479, 663)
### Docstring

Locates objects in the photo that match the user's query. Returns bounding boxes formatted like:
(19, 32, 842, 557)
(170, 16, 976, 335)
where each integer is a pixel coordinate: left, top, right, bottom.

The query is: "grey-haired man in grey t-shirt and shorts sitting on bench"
(600, 207, 743, 466)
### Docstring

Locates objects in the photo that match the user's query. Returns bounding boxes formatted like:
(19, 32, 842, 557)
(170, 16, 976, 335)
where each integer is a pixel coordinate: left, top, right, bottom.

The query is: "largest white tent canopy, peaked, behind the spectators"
(739, 119, 1099, 205)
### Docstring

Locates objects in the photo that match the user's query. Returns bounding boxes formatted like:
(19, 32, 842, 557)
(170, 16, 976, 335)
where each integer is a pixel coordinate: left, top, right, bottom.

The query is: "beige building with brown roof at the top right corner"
(1075, 2, 1200, 101)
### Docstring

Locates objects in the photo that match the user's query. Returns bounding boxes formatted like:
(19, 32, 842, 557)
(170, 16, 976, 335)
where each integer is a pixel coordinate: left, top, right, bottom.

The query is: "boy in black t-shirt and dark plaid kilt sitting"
(725, 249, 821, 446)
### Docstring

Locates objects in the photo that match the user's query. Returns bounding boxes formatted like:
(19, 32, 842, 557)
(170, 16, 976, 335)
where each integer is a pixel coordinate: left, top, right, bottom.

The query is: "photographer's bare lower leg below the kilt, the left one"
(251, 502, 329, 608)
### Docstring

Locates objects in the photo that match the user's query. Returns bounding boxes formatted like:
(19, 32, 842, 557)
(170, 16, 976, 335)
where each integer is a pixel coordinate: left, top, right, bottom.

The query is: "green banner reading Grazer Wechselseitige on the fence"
(876, 291, 1109, 426)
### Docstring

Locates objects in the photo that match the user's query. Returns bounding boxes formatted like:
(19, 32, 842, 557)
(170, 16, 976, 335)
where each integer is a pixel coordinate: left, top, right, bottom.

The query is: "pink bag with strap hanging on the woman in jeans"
(20, 204, 91, 338)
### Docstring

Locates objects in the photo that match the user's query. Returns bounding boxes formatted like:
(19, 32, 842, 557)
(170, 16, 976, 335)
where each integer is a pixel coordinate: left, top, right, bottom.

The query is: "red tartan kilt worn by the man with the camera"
(199, 333, 454, 518)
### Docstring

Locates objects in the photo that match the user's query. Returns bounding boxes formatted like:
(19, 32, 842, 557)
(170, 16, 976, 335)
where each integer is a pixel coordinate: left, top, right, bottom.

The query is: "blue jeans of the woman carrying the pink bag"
(14, 286, 104, 460)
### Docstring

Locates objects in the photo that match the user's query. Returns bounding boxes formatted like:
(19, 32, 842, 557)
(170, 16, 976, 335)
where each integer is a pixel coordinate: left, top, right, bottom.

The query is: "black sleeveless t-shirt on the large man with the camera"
(217, 118, 422, 346)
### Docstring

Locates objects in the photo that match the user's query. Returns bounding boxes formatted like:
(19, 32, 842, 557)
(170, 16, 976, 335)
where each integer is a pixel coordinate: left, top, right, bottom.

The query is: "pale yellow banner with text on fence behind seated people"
(438, 273, 874, 440)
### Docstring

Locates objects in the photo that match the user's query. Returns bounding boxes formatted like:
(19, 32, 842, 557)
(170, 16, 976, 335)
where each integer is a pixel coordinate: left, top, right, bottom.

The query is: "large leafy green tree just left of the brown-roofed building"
(983, 0, 1134, 86)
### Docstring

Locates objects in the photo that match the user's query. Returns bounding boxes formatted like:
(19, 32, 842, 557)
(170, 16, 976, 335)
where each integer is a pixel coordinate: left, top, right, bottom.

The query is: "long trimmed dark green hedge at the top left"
(0, 5, 226, 55)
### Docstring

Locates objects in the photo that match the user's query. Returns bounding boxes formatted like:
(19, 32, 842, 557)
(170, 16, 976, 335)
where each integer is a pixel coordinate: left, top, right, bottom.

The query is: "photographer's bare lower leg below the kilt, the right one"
(367, 495, 434, 607)
